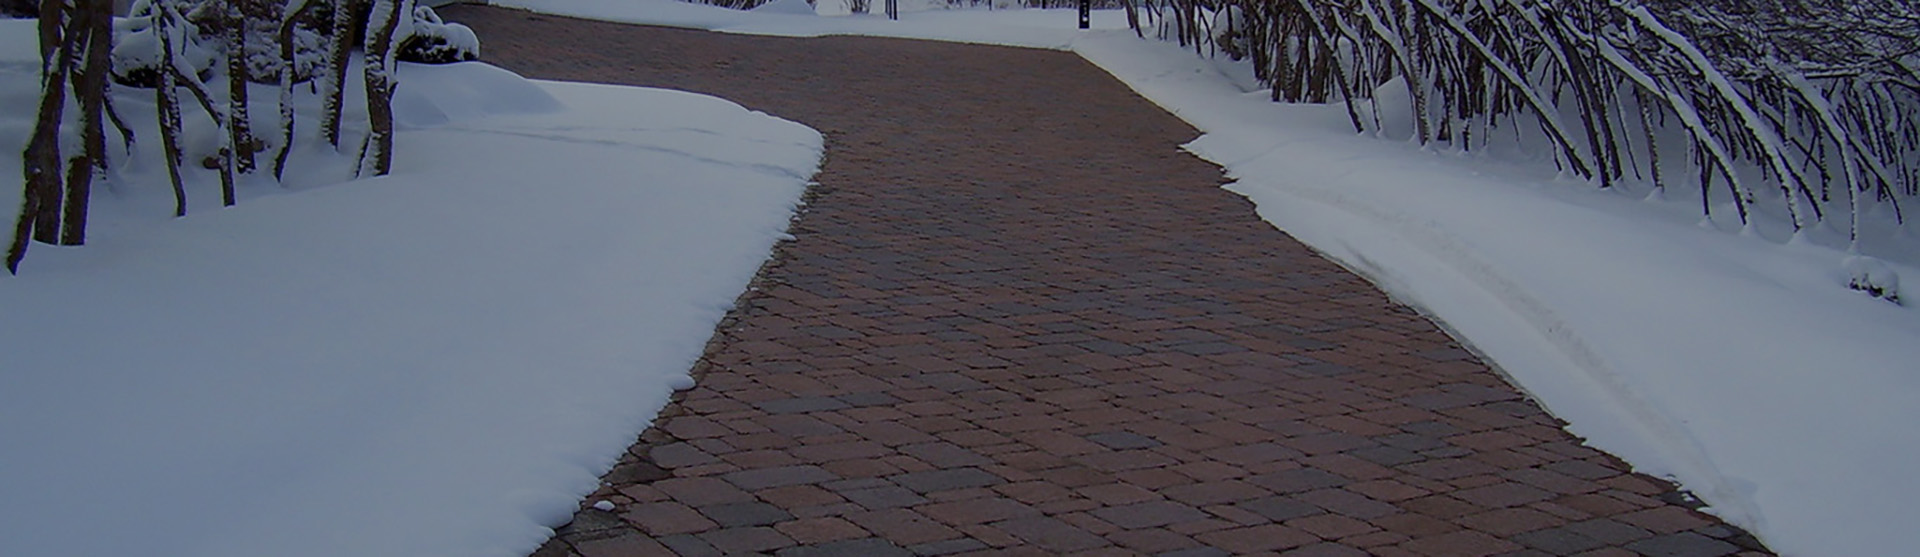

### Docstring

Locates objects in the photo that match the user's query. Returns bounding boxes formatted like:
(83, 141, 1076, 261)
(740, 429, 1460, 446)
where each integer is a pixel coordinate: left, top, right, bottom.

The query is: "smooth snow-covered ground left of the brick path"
(0, 21, 822, 557)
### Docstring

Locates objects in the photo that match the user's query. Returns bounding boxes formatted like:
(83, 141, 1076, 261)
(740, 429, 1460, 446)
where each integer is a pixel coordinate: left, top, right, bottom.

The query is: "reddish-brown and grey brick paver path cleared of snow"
(444, 6, 1764, 557)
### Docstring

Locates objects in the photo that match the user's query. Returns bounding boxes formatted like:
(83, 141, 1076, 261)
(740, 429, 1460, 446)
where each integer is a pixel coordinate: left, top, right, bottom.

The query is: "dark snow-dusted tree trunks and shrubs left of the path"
(0, 0, 478, 273)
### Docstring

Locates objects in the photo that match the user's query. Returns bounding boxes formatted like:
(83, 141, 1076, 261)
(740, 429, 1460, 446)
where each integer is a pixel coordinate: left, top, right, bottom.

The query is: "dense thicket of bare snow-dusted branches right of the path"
(1127, 0, 1920, 248)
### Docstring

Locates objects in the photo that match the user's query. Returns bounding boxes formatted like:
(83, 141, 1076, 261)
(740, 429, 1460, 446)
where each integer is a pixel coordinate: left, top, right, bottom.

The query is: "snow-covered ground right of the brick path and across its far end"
(493, 0, 1920, 555)
